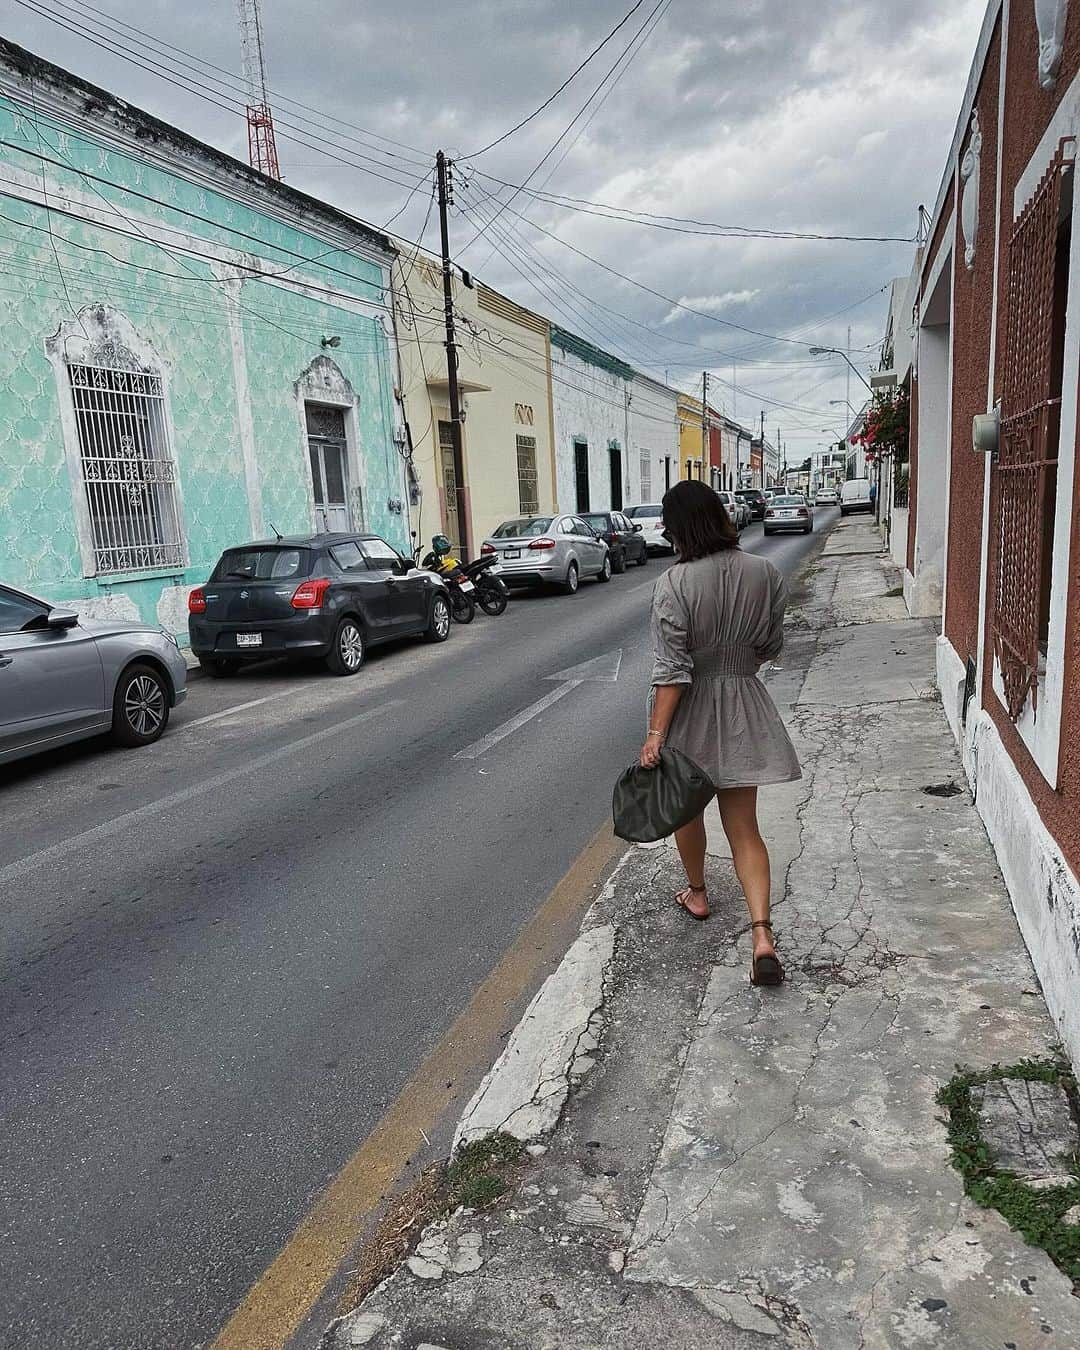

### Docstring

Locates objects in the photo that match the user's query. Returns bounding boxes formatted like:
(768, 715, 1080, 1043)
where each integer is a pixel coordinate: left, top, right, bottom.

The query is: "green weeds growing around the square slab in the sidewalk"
(937, 1053, 1080, 1292)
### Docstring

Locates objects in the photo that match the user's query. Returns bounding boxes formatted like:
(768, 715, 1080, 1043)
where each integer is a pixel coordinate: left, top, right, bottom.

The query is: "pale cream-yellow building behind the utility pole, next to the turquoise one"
(394, 244, 555, 558)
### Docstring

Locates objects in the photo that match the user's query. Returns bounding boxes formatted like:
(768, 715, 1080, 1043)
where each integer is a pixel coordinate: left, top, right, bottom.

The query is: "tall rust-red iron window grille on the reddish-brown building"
(991, 139, 1075, 721)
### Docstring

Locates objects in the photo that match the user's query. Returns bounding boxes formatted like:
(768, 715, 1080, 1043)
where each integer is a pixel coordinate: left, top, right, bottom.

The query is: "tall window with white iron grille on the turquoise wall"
(68, 365, 186, 575)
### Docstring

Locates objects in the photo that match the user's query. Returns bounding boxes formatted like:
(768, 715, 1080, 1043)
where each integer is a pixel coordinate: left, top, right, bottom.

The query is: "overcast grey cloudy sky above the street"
(4, 0, 984, 462)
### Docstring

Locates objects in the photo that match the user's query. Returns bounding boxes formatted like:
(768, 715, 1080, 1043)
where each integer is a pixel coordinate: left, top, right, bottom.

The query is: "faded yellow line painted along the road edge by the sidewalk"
(212, 825, 625, 1350)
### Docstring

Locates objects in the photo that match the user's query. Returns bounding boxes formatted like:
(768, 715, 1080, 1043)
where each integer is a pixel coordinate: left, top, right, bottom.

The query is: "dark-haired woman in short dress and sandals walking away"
(640, 482, 802, 984)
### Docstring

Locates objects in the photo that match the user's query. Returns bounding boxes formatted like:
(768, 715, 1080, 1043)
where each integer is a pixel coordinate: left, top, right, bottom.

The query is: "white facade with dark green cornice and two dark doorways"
(551, 325, 641, 512)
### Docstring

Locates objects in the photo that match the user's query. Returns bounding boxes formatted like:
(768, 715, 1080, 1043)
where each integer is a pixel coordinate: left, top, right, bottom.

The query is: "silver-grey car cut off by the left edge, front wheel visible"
(0, 586, 188, 764)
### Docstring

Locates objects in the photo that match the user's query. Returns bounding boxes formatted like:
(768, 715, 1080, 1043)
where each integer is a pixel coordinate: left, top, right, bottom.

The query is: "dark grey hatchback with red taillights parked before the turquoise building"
(188, 533, 450, 675)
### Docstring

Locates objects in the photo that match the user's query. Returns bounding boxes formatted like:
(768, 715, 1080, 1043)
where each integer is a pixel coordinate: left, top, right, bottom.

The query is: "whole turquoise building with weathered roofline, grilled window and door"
(0, 39, 409, 633)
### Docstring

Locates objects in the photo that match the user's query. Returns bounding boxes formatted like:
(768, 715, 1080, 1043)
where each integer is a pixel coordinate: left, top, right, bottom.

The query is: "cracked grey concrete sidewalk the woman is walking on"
(327, 522, 1080, 1350)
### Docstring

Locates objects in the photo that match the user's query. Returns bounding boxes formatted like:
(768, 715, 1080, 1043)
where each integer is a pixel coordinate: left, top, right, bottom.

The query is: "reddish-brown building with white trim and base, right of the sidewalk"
(892, 0, 1080, 1062)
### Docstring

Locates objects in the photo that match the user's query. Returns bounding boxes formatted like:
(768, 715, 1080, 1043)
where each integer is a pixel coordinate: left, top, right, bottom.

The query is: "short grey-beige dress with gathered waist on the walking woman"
(649, 548, 802, 787)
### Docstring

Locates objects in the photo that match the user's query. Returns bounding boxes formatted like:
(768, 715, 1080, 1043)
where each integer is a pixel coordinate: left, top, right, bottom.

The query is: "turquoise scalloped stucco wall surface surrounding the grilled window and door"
(0, 77, 404, 632)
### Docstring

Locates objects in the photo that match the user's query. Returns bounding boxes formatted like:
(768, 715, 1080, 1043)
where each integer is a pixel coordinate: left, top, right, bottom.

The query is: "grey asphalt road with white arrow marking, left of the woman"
(0, 513, 834, 1350)
